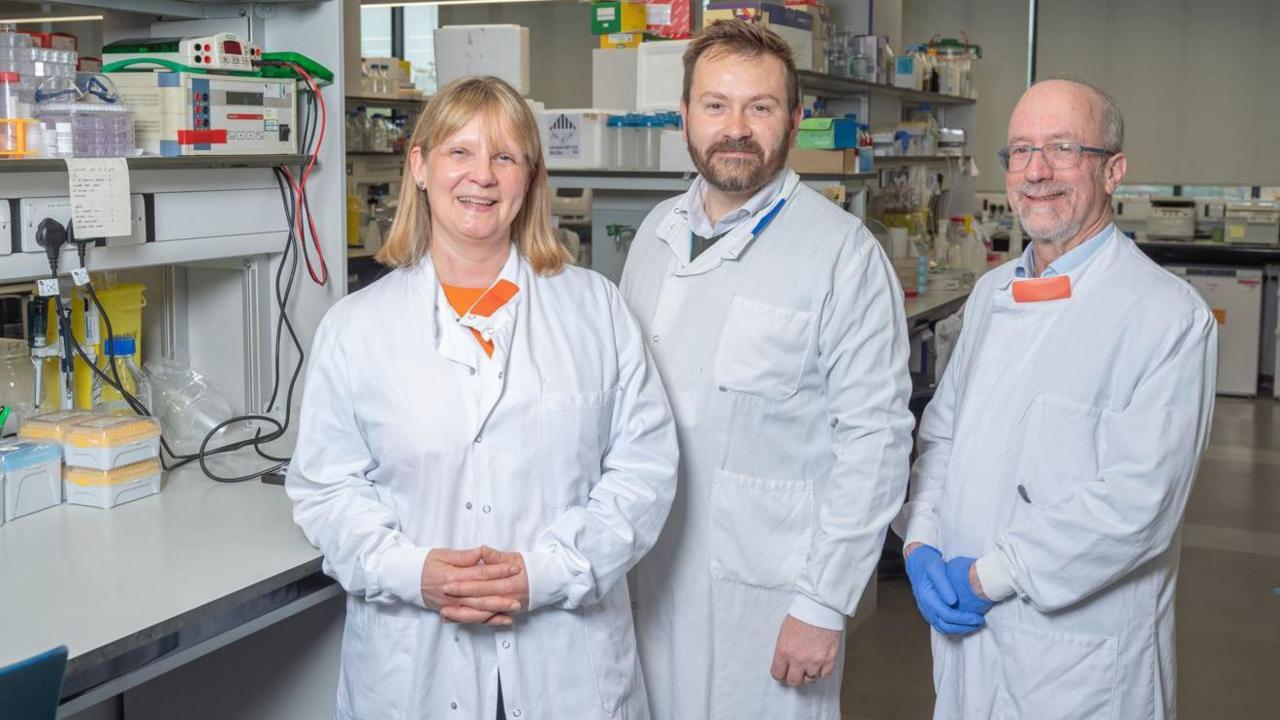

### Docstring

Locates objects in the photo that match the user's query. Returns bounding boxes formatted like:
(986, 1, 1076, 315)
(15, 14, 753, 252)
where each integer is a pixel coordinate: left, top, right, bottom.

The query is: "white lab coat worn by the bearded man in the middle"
(622, 172, 911, 720)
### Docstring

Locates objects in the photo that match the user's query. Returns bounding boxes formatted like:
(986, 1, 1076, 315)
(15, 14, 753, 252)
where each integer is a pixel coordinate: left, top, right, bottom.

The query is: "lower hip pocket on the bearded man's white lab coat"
(712, 470, 813, 588)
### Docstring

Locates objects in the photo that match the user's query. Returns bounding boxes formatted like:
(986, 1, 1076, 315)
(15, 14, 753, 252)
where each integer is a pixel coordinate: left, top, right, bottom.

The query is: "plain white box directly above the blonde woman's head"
(435, 24, 529, 95)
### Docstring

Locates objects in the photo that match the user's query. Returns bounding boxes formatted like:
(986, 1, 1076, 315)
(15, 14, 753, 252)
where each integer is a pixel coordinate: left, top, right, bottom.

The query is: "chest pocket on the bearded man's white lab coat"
(712, 296, 814, 400)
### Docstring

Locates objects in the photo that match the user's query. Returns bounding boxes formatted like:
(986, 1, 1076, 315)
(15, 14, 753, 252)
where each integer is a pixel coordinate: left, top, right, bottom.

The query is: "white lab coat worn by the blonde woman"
(287, 250, 676, 720)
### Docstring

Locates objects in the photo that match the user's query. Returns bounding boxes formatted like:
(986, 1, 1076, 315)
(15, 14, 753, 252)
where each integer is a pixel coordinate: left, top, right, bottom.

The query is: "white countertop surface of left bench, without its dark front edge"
(0, 468, 320, 666)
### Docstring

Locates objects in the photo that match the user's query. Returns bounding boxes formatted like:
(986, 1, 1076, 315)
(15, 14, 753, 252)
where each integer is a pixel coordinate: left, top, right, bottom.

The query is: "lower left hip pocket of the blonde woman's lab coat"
(338, 597, 417, 720)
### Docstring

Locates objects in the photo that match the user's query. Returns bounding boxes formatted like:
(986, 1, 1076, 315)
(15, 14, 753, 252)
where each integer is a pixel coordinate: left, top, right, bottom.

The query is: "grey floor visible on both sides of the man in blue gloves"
(844, 397, 1280, 720)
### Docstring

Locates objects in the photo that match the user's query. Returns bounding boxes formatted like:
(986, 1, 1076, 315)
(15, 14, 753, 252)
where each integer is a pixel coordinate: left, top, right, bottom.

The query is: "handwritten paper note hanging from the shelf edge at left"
(67, 158, 133, 237)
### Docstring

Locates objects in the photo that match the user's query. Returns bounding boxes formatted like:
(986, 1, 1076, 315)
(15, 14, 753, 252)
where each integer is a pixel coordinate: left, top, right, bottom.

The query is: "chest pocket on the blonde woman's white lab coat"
(539, 388, 617, 507)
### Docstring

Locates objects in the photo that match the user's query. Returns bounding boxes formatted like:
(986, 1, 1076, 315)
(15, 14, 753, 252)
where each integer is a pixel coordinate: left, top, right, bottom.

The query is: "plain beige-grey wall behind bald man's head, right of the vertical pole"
(1037, 0, 1280, 184)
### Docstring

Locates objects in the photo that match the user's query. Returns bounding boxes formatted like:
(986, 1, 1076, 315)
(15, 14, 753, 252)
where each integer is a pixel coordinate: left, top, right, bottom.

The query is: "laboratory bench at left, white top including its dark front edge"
(0, 468, 342, 715)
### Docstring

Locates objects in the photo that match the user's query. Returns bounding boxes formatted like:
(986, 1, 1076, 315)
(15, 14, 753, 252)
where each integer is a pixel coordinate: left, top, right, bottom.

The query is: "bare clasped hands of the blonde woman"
(422, 546, 529, 625)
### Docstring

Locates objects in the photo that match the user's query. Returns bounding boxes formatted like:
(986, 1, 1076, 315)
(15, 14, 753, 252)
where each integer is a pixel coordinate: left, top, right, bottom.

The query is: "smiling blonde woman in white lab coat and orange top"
(287, 77, 676, 720)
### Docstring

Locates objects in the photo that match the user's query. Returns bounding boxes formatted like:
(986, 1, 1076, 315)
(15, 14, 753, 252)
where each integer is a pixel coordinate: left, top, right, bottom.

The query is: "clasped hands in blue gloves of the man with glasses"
(906, 543, 992, 635)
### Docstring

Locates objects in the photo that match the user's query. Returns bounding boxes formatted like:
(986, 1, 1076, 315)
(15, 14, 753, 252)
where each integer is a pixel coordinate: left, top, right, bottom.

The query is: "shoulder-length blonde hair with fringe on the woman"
(376, 77, 570, 275)
